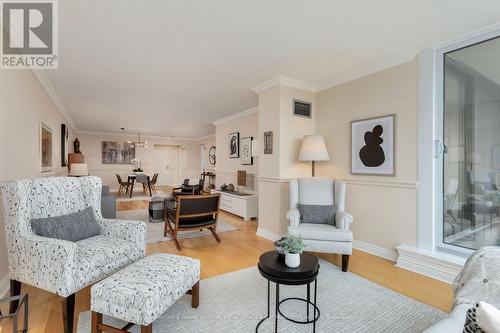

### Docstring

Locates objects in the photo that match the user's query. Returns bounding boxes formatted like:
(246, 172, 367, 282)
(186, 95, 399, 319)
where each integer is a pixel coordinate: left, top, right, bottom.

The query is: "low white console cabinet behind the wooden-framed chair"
(211, 190, 259, 221)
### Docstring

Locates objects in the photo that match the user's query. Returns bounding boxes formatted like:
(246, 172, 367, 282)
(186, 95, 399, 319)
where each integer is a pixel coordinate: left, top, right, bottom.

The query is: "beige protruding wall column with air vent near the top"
(258, 85, 316, 235)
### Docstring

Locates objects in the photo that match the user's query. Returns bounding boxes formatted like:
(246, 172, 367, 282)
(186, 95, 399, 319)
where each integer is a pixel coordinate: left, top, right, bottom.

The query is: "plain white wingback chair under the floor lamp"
(287, 177, 353, 272)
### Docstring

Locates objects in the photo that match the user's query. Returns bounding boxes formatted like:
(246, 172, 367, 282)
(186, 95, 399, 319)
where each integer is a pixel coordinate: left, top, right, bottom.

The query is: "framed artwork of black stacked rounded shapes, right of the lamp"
(351, 114, 395, 176)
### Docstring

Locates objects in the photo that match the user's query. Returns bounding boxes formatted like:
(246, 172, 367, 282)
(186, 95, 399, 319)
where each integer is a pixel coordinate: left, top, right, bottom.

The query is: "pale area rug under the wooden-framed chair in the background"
(116, 209, 239, 243)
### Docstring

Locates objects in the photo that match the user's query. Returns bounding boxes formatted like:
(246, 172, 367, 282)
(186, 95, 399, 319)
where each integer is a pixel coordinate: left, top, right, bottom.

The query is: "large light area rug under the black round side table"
(77, 260, 446, 333)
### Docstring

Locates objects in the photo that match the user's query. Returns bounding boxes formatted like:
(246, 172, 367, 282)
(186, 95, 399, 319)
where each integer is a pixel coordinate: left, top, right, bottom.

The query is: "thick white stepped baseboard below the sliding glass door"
(396, 245, 465, 284)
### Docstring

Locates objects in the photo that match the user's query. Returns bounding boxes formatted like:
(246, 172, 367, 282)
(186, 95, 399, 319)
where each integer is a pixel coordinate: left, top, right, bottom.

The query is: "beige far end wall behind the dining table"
(78, 134, 201, 191)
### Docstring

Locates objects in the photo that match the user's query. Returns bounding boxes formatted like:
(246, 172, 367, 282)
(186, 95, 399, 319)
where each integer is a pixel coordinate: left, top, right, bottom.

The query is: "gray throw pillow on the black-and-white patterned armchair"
(31, 207, 101, 242)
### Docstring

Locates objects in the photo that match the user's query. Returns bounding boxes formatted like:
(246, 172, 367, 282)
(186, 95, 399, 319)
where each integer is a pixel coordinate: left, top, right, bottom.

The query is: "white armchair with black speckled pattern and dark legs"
(0, 177, 146, 333)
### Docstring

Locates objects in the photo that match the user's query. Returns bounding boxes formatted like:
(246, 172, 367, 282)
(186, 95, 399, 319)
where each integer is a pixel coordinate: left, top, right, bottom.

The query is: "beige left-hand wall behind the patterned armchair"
(0, 70, 74, 287)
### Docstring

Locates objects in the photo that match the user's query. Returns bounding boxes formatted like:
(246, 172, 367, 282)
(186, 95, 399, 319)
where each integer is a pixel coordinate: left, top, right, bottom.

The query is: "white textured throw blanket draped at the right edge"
(453, 246, 500, 308)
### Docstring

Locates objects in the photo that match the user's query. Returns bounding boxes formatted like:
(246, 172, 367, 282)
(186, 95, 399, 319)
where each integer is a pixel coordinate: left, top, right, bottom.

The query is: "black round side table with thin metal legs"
(255, 251, 320, 332)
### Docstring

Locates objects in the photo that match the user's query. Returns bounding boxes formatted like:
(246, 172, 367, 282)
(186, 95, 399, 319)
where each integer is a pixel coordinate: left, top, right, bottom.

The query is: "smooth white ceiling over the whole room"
(47, 0, 500, 138)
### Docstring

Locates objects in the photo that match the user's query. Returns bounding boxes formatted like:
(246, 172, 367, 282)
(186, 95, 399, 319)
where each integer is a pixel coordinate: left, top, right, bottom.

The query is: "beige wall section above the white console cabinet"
(215, 112, 260, 192)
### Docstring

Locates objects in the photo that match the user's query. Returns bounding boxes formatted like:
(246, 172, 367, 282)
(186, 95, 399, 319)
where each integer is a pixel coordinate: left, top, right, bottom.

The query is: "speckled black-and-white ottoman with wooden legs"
(90, 253, 200, 333)
